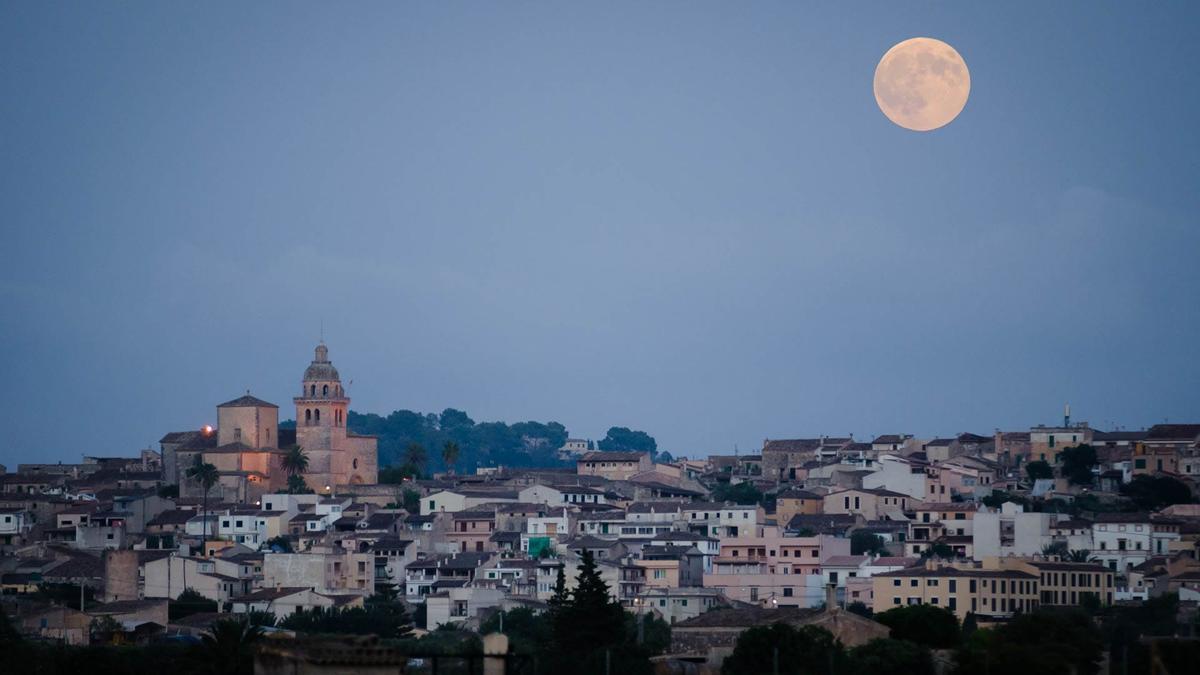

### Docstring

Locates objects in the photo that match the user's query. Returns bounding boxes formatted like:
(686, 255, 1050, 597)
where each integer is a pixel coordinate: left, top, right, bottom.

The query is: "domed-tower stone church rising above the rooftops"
(158, 341, 379, 503)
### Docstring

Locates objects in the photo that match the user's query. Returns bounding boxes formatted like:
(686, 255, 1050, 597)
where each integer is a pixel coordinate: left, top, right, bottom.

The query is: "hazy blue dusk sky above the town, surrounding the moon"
(0, 1, 1200, 471)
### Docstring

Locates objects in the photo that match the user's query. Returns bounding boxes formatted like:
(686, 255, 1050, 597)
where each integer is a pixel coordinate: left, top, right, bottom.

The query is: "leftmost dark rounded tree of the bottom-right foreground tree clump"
(721, 622, 845, 675)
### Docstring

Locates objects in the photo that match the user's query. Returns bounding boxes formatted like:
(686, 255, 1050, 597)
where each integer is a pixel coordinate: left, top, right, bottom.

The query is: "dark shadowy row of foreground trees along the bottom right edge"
(721, 596, 1200, 675)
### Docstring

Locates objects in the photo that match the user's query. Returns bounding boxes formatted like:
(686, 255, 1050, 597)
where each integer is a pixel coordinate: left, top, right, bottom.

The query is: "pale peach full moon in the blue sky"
(875, 37, 971, 131)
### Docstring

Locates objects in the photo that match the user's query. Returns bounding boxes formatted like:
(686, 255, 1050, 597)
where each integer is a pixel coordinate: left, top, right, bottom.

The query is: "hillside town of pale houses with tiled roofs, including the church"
(0, 344, 1200, 668)
